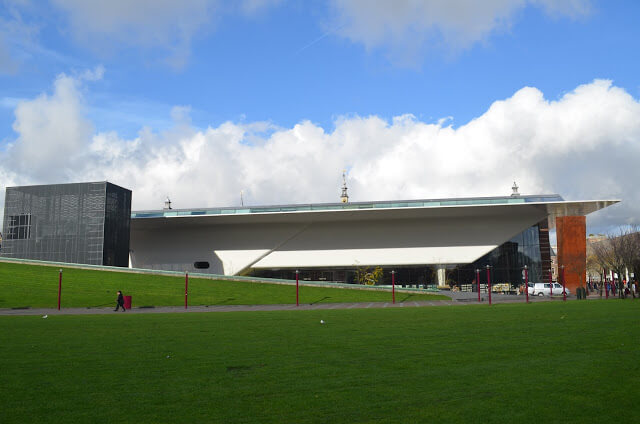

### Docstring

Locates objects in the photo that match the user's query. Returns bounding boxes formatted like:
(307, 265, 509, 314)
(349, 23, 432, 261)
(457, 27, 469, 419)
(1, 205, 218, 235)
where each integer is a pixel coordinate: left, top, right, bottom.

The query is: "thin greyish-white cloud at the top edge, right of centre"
(330, 0, 590, 64)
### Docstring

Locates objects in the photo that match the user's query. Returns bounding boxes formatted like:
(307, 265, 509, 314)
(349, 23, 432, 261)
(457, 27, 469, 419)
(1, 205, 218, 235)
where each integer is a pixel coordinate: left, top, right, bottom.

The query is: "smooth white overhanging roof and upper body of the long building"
(131, 195, 618, 274)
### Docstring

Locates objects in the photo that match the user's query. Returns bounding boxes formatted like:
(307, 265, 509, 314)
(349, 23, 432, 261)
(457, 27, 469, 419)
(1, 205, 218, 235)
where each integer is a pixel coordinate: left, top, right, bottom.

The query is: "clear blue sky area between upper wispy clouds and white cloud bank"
(0, 1, 640, 138)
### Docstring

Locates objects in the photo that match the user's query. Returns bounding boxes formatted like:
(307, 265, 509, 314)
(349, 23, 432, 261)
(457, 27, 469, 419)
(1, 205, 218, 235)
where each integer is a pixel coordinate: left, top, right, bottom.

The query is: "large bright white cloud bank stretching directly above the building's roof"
(0, 76, 640, 232)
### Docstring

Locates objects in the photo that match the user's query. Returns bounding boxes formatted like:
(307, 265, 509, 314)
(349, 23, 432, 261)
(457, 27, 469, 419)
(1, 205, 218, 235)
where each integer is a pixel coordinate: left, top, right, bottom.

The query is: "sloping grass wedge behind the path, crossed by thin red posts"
(0, 262, 448, 308)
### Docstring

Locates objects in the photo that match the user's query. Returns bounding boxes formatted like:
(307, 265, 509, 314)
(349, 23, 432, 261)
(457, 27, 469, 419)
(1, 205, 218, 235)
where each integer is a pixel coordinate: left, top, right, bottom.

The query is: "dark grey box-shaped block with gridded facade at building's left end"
(0, 182, 131, 266)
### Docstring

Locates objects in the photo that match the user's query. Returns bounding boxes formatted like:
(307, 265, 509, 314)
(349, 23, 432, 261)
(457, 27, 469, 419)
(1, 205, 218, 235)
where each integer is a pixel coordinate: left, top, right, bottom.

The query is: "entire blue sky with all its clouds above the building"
(0, 0, 640, 232)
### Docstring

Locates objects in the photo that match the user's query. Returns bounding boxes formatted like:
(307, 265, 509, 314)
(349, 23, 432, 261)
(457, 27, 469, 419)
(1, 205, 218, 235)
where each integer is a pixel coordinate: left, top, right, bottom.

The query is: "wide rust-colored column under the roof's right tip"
(556, 216, 587, 293)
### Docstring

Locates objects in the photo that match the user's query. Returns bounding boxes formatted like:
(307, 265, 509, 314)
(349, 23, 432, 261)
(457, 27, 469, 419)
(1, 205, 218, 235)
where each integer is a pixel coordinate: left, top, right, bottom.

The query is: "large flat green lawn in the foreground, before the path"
(0, 300, 640, 424)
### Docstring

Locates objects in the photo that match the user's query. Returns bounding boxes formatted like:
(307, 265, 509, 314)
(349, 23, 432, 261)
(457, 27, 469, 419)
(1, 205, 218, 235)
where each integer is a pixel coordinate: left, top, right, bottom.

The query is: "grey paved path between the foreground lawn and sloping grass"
(0, 292, 568, 316)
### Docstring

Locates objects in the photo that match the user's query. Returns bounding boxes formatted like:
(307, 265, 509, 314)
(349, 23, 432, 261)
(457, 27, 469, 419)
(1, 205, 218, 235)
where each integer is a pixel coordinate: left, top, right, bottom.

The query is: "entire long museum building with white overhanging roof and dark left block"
(0, 182, 618, 288)
